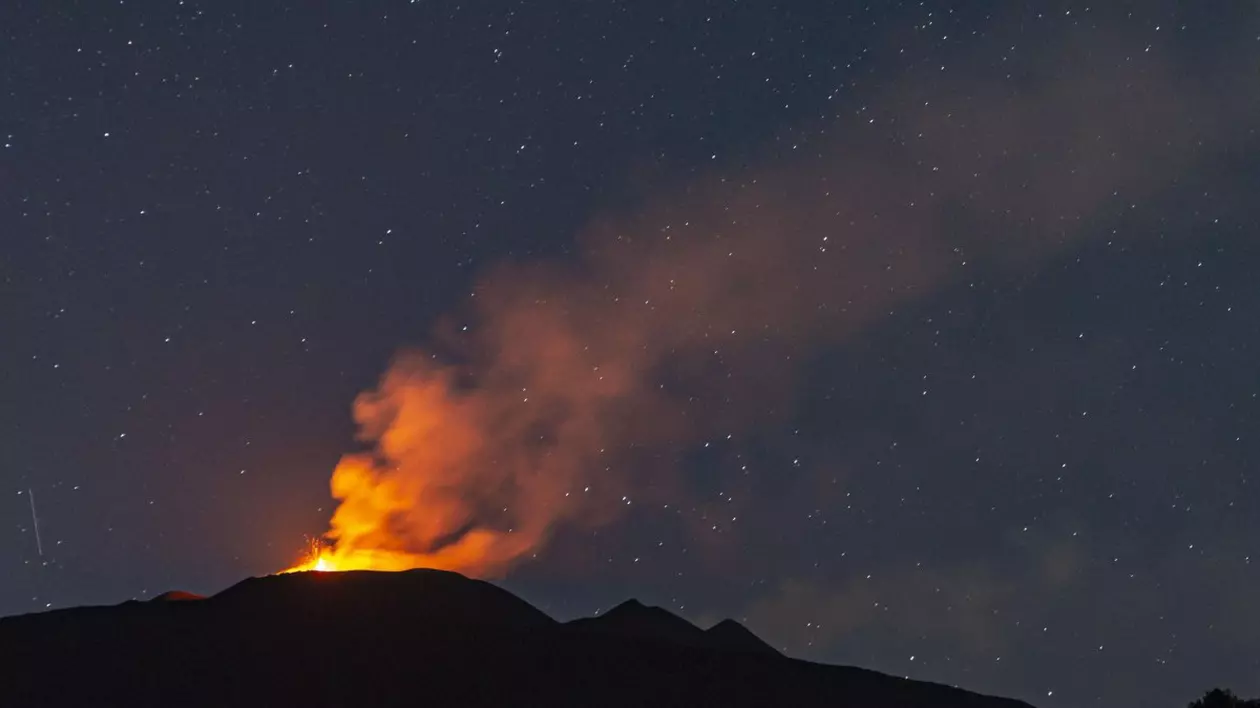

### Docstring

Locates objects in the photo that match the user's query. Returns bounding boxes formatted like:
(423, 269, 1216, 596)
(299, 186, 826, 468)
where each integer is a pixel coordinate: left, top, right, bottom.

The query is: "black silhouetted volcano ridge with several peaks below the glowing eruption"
(0, 569, 1029, 708)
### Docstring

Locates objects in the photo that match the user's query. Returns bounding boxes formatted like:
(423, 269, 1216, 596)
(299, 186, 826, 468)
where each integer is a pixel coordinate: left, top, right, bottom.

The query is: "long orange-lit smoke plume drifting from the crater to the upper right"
(309, 30, 1260, 576)
